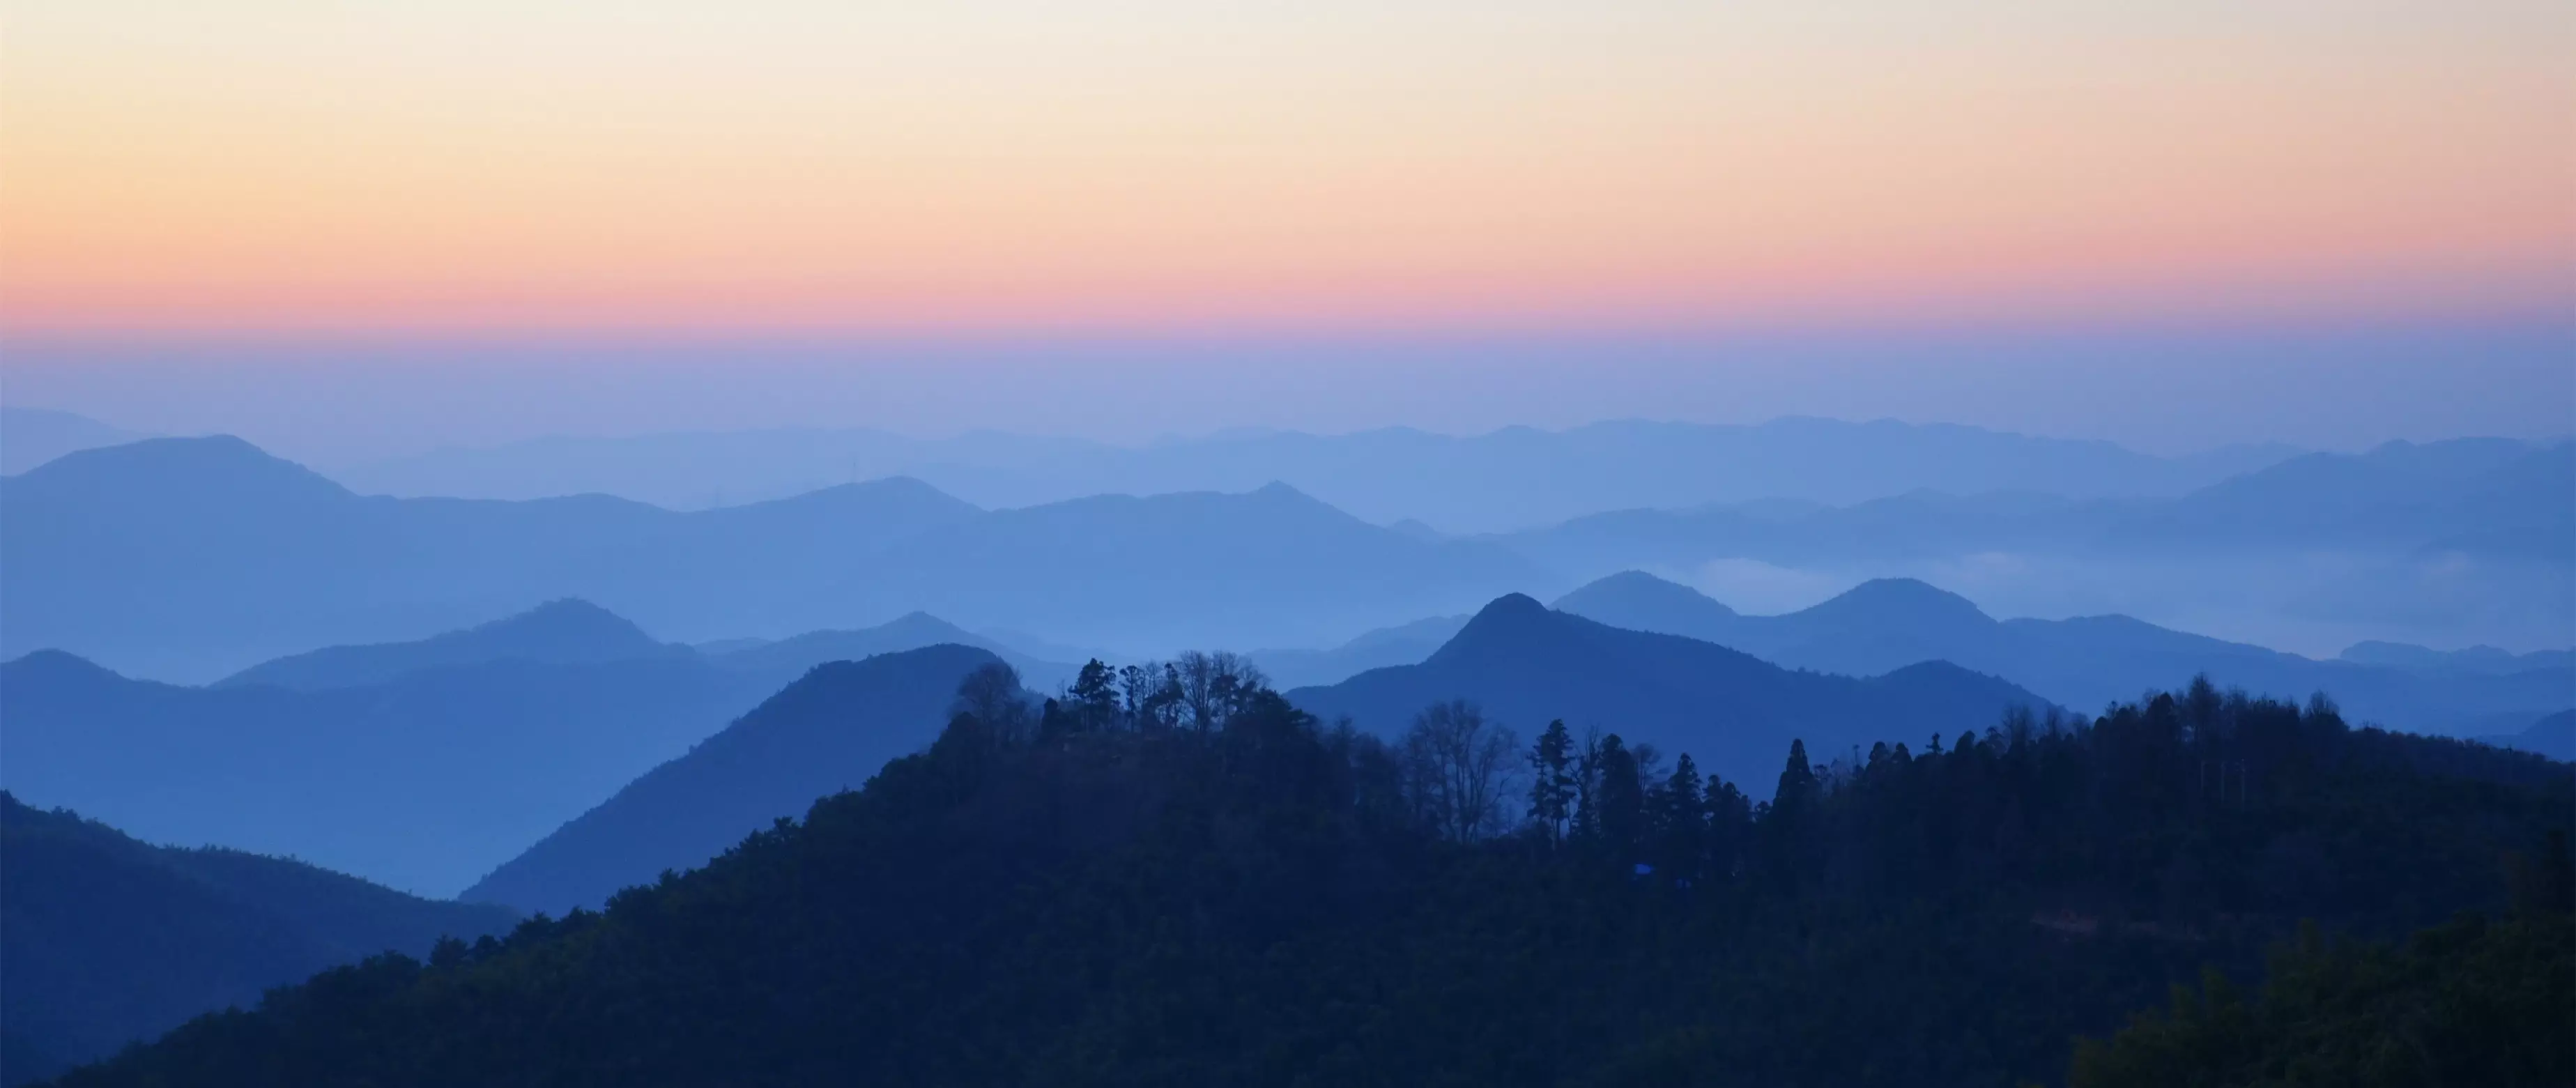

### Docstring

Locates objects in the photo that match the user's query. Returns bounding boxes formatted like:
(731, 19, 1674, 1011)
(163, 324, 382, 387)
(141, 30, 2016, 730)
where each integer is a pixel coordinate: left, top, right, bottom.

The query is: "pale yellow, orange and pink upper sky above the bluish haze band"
(0, 0, 2576, 332)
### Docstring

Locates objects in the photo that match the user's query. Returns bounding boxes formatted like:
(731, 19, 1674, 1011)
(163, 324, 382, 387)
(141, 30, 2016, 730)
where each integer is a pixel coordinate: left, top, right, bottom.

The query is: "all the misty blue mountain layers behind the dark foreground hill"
(0, 415, 2576, 1078)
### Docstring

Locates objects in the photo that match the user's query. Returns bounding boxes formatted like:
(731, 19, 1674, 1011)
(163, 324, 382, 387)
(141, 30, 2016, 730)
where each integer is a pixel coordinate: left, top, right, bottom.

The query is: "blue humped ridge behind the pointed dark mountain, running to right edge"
(1556, 572, 2576, 733)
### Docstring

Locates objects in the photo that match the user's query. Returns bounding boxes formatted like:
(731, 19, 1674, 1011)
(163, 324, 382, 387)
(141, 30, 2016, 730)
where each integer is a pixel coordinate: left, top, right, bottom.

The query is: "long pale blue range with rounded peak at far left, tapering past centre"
(0, 438, 1525, 681)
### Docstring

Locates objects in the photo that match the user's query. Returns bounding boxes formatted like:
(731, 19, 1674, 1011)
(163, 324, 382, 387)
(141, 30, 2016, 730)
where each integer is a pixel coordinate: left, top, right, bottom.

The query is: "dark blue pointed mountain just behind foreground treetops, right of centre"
(1288, 593, 2048, 797)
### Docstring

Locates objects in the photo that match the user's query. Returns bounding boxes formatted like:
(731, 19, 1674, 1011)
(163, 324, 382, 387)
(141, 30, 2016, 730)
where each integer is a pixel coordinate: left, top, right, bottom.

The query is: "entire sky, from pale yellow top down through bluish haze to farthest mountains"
(0, 0, 2576, 446)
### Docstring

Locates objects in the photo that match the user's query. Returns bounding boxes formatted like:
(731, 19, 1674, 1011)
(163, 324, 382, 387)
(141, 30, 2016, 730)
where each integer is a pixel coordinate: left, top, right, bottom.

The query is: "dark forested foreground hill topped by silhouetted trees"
(45, 671, 2576, 1088)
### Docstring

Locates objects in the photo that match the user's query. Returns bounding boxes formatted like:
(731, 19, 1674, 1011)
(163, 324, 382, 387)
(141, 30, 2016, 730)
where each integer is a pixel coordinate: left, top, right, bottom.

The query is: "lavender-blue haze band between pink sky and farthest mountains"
(0, 322, 2576, 464)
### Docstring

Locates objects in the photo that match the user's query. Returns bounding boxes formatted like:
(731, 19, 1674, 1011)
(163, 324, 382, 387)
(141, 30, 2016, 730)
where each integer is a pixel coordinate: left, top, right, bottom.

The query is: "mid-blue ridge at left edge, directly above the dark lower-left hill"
(0, 650, 765, 895)
